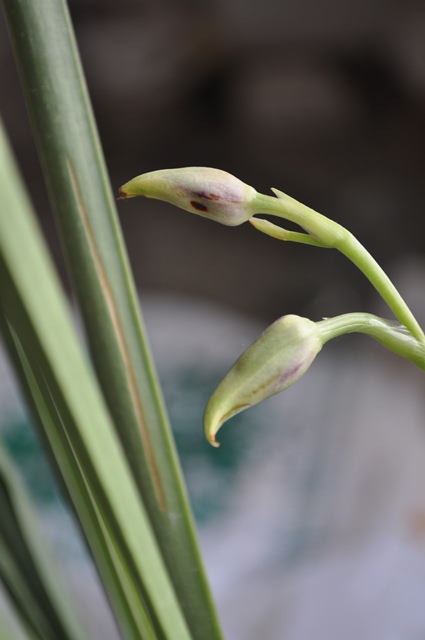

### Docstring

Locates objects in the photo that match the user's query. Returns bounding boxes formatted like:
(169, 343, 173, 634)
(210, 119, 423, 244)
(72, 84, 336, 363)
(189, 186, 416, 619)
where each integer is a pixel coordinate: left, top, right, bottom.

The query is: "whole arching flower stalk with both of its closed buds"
(119, 167, 425, 446)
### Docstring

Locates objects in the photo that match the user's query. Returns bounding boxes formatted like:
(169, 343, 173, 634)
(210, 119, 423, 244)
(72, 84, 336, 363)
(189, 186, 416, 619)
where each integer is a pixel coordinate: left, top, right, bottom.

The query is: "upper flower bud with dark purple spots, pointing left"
(119, 167, 256, 227)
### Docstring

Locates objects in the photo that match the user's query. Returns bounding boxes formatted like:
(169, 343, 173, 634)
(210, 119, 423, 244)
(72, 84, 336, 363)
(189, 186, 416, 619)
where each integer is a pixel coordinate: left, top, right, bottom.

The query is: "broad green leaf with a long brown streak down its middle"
(2, 0, 221, 640)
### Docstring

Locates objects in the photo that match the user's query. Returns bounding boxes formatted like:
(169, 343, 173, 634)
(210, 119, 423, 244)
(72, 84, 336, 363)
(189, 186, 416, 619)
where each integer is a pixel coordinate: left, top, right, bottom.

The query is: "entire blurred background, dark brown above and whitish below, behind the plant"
(0, 0, 425, 640)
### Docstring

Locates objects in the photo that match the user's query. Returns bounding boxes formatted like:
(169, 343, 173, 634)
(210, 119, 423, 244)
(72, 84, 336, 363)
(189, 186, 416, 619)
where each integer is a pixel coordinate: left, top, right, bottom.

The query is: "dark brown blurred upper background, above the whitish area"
(0, 0, 425, 321)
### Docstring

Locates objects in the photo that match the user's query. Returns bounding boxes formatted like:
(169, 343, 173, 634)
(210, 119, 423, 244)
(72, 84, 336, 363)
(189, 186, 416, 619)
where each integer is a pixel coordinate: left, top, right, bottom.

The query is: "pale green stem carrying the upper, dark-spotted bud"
(252, 189, 425, 344)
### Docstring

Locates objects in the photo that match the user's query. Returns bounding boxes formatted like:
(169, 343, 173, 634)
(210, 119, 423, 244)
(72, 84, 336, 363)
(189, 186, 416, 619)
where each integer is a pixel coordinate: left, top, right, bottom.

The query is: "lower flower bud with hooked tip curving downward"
(204, 315, 323, 446)
